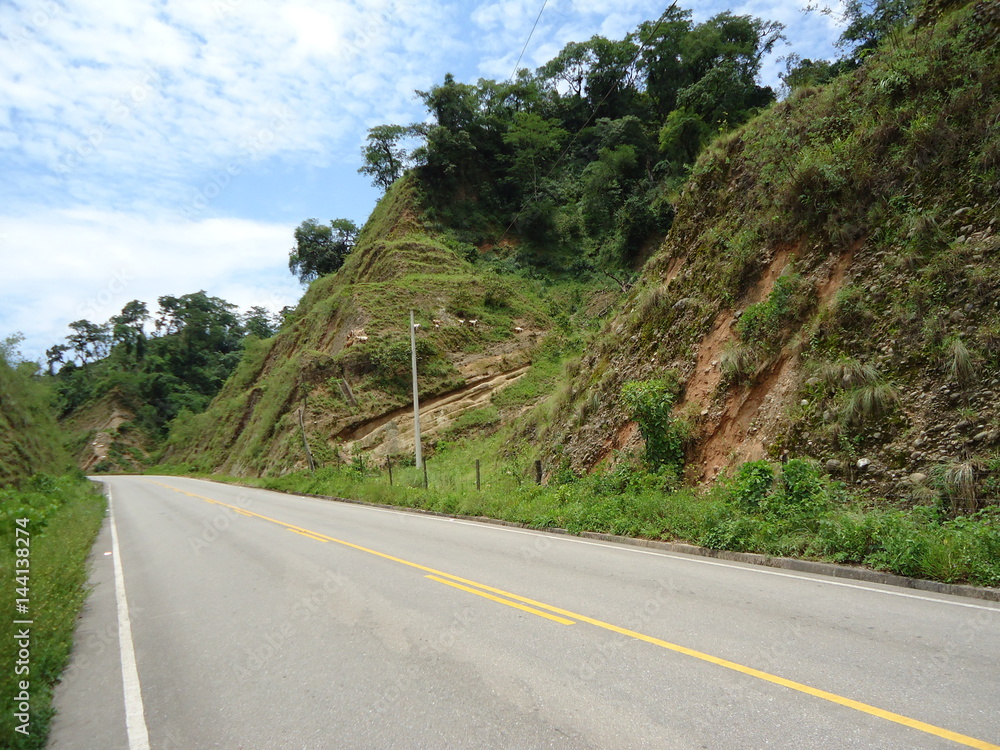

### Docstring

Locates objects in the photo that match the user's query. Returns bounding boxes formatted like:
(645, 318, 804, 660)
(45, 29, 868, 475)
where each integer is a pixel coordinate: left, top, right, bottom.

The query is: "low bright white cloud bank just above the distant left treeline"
(0, 209, 302, 358)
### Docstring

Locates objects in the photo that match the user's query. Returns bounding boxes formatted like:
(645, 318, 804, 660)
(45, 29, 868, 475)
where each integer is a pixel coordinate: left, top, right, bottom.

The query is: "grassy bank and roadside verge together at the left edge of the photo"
(0, 344, 105, 750)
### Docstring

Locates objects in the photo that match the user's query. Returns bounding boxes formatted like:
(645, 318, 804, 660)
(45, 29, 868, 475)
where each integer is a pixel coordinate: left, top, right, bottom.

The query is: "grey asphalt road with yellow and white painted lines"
(49, 477, 1000, 750)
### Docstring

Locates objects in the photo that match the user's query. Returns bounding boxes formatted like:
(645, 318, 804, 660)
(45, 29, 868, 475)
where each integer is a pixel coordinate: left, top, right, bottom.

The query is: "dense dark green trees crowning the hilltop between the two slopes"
(361, 6, 782, 275)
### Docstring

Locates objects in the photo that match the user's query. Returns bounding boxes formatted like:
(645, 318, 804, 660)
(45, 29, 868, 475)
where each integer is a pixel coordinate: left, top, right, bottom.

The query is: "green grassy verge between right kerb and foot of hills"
(188, 434, 1000, 586)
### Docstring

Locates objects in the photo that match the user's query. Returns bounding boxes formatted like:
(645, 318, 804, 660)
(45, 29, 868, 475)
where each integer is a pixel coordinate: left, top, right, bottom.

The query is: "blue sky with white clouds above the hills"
(0, 0, 839, 359)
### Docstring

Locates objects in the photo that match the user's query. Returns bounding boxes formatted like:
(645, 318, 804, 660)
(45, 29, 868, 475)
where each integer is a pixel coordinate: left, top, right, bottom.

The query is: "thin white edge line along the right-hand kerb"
(172, 477, 1000, 613)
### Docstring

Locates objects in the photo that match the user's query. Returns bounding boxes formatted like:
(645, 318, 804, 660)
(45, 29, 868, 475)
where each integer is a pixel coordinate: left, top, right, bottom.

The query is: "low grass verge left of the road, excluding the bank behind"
(0, 475, 106, 750)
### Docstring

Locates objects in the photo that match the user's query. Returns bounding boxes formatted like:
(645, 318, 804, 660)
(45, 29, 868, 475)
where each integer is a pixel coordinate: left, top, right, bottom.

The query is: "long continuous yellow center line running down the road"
(145, 479, 1000, 750)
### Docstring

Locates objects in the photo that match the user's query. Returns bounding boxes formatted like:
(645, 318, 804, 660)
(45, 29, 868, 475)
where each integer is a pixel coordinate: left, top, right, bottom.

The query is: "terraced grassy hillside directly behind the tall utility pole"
(164, 178, 600, 475)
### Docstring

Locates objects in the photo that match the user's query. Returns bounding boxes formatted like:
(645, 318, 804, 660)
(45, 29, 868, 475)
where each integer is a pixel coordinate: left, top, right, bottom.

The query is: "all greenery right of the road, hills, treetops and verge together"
(109, 0, 1000, 600)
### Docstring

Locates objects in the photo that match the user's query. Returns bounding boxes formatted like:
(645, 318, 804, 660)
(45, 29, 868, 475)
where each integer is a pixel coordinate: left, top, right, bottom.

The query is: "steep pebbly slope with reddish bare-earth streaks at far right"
(540, 2, 1000, 506)
